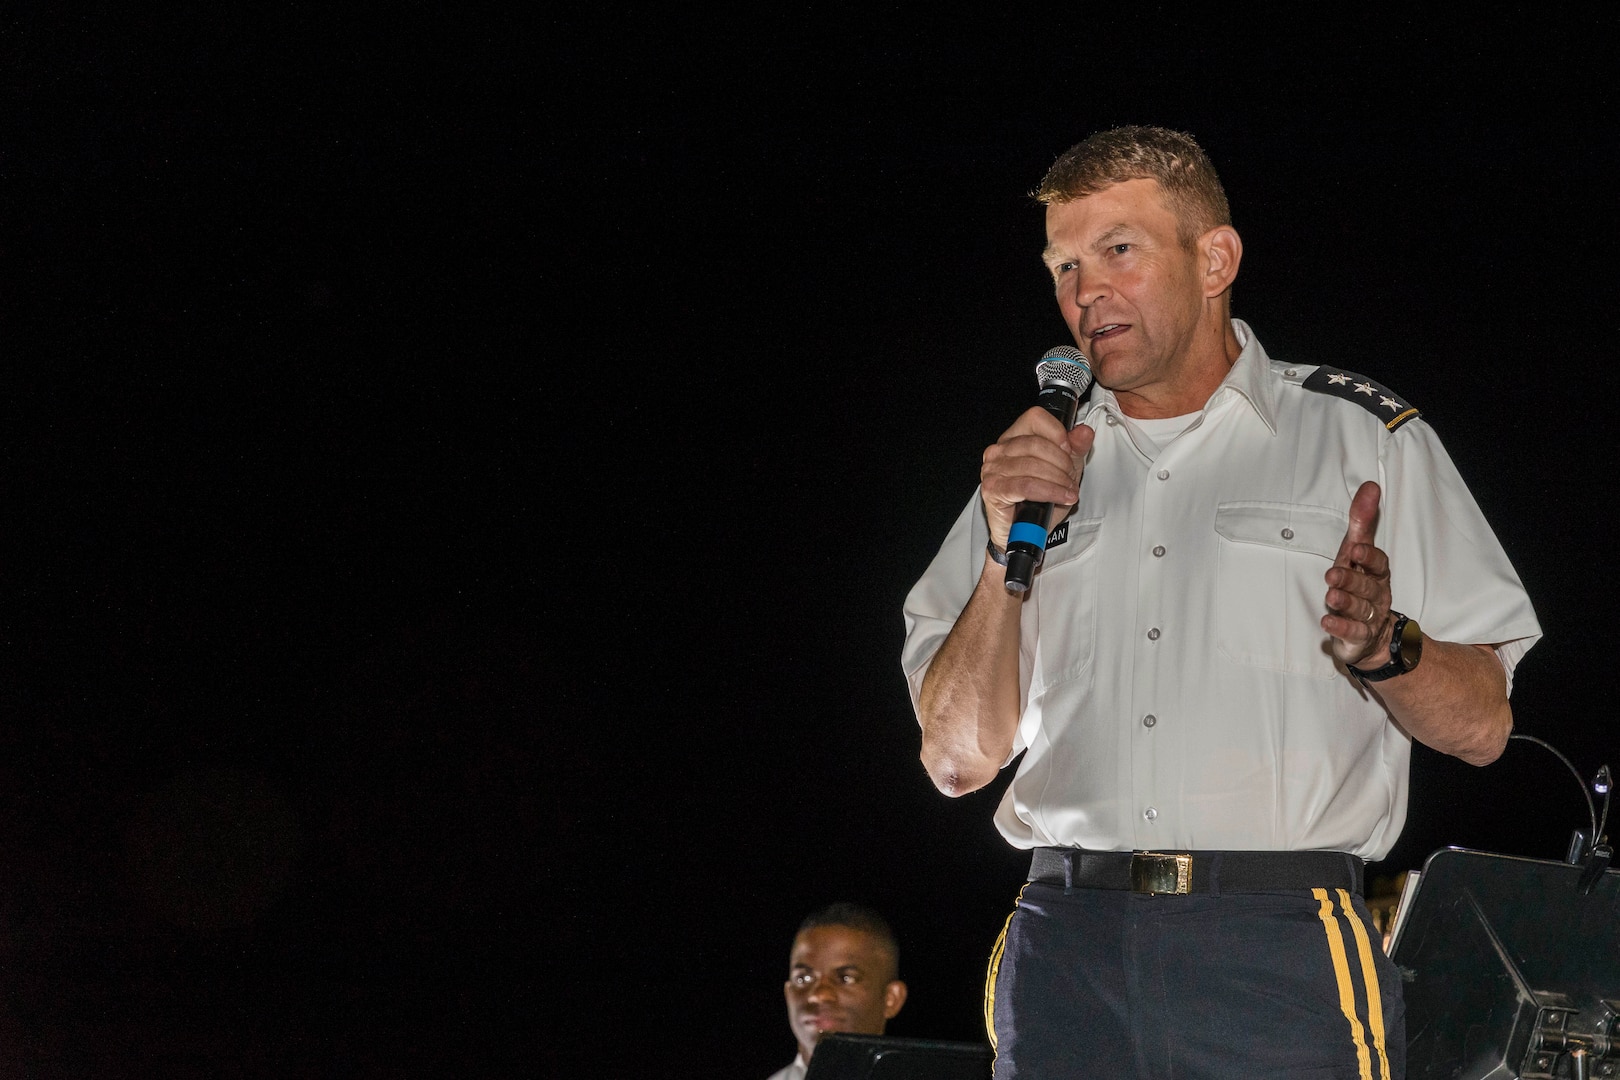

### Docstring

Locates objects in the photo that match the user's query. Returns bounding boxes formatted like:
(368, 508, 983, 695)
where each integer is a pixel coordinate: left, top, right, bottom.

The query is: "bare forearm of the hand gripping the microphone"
(917, 557, 1022, 797)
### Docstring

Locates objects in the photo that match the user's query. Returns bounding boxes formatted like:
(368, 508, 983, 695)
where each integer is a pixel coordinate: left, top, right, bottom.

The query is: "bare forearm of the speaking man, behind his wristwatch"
(1371, 636, 1513, 764)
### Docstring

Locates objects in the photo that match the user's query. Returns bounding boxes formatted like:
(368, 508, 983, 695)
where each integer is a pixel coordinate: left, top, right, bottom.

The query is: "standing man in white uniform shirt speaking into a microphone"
(904, 128, 1541, 1080)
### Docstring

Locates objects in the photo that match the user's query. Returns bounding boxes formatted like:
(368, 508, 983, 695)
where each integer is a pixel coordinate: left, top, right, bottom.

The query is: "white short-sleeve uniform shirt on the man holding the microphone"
(902, 321, 1541, 860)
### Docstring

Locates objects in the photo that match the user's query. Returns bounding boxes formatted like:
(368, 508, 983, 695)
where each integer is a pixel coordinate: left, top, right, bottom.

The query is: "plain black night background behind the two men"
(0, 2, 1620, 1078)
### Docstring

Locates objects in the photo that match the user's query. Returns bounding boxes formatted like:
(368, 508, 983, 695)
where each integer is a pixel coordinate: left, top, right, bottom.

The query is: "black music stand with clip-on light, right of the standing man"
(1392, 847, 1620, 1080)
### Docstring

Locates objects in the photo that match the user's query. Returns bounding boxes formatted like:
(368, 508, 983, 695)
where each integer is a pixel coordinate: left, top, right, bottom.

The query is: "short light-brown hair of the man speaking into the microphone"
(1032, 126, 1231, 248)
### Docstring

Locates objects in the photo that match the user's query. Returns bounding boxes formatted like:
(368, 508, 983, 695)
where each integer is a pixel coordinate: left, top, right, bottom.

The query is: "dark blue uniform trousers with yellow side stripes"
(985, 882, 1406, 1080)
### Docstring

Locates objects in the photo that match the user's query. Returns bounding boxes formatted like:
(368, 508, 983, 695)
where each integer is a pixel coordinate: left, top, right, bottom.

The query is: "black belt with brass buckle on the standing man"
(1029, 847, 1366, 895)
